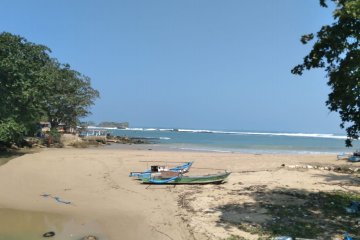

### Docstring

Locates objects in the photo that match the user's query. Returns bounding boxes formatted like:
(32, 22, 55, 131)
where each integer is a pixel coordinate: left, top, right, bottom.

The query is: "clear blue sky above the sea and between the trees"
(0, 0, 343, 133)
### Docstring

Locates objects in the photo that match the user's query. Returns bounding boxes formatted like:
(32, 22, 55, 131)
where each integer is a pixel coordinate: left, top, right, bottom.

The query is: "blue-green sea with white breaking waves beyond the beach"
(89, 127, 360, 154)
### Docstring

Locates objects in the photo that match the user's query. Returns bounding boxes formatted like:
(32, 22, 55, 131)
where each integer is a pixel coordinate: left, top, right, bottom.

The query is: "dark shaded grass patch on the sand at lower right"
(219, 190, 360, 239)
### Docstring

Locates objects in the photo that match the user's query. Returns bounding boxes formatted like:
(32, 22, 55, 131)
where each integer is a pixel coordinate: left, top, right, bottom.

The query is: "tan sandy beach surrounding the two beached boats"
(0, 146, 360, 240)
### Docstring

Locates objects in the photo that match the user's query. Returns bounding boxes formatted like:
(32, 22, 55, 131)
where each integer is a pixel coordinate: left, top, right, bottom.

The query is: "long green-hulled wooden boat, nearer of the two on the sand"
(140, 171, 231, 184)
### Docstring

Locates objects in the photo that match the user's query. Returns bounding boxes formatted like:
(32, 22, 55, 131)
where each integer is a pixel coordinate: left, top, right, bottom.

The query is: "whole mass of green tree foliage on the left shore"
(0, 32, 99, 150)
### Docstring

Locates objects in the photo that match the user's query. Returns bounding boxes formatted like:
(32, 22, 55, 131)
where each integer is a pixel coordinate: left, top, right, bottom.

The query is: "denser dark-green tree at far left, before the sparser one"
(0, 32, 50, 143)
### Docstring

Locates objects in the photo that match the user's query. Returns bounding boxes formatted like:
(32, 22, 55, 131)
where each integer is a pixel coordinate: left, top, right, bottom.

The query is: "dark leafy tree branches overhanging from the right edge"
(291, 0, 360, 147)
